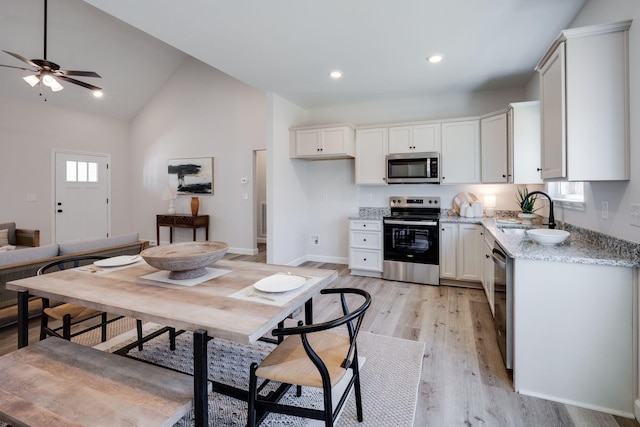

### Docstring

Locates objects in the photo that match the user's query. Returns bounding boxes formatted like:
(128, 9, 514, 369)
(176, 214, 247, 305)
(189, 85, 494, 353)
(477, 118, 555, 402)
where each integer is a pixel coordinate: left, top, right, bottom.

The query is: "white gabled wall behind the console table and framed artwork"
(131, 58, 267, 253)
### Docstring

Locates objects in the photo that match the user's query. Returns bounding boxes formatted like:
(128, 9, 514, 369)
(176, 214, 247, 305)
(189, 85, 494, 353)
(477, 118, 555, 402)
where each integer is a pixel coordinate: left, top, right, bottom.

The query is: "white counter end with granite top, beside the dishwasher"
(482, 219, 638, 417)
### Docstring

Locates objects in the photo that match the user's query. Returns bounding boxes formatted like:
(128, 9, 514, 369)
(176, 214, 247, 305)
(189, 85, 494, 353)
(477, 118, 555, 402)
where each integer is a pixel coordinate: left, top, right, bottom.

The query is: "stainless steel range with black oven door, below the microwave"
(382, 196, 440, 285)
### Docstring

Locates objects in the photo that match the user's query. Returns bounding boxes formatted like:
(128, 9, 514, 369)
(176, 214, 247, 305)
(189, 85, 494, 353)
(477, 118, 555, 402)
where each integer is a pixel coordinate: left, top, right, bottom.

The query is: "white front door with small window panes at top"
(54, 152, 111, 243)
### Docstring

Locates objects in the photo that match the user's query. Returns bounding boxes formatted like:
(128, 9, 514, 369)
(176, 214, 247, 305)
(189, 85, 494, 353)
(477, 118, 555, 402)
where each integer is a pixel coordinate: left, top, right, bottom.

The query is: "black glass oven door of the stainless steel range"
(384, 219, 440, 265)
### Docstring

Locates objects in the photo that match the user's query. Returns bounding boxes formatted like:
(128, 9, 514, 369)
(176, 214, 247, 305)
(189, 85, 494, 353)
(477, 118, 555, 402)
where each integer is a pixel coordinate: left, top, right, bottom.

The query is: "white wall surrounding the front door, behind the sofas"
(0, 96, 135, 245)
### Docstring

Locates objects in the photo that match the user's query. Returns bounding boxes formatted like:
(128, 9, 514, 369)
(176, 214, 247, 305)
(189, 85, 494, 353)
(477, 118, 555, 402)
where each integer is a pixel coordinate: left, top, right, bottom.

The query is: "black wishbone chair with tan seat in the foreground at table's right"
(247, 288, 371, 427)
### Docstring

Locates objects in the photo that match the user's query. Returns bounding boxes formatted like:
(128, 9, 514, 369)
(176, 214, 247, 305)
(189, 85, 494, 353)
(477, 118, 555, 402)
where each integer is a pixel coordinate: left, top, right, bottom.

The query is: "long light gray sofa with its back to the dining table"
(0, 233, 149, 328)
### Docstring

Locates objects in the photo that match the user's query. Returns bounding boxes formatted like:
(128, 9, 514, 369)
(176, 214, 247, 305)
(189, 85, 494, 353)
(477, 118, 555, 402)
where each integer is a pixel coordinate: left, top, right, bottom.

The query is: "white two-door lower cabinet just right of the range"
(440, 223, 484, 282)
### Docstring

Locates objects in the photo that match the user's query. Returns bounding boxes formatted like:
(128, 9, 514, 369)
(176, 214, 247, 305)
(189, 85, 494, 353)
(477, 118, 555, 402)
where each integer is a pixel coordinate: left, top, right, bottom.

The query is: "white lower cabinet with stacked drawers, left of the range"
(349, 219, 382, 277)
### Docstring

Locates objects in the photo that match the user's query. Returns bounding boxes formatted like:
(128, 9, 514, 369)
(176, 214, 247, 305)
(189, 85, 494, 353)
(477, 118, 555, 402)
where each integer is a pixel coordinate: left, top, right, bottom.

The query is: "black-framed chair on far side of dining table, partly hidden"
(37, 255, 176, 350)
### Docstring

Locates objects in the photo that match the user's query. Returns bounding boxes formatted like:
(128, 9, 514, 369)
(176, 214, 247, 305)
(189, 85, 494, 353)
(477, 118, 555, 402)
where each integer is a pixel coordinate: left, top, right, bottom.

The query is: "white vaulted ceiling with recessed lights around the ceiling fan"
(0, 0, 586, 119)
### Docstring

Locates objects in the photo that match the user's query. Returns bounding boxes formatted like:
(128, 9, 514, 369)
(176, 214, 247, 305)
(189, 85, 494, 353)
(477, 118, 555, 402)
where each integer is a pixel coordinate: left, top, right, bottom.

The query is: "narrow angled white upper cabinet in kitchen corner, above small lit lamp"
(480, 112, 509, 184)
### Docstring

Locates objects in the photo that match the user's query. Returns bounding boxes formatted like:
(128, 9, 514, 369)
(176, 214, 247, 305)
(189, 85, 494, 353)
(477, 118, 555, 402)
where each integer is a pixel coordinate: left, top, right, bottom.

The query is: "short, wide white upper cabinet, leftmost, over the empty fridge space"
(290, 126, 355, 160)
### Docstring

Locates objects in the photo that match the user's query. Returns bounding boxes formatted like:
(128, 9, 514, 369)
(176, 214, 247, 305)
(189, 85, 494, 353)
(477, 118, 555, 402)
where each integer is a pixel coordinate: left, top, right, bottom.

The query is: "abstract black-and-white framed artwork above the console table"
(168, 157, 213, 195)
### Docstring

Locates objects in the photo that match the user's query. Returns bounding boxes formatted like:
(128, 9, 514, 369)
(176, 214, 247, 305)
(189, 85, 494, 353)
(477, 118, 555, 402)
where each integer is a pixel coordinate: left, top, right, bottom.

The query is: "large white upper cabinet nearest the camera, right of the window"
(536, 21, 631, 181)
